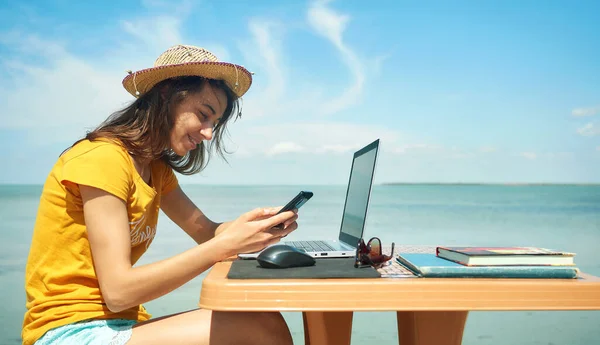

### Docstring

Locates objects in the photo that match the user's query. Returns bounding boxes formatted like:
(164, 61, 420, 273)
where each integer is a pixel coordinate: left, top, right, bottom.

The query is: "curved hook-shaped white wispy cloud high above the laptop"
(307, 1, 364, 114)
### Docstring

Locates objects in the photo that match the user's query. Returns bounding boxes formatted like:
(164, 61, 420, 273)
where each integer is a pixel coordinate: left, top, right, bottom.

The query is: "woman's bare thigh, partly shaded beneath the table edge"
(127, 309, 293, 345)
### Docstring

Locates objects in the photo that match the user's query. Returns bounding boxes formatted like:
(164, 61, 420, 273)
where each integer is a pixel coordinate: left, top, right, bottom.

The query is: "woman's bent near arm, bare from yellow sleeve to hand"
(80, 185, 296, 312)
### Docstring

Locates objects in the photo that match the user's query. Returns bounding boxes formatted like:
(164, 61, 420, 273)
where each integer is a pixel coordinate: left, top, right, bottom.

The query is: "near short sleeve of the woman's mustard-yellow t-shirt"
(61, 143, 132, 201)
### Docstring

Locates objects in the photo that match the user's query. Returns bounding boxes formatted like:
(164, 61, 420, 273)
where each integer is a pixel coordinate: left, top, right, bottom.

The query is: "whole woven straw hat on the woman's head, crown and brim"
(123, 44, 252, 97)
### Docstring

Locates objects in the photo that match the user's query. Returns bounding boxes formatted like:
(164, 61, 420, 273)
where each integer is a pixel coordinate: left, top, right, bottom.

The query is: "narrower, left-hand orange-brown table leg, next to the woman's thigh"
(302, 311, 353, 345)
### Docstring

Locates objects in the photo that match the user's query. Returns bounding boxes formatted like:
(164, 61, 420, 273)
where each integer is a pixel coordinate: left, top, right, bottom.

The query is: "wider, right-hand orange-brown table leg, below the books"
(396, 311, 468, 345)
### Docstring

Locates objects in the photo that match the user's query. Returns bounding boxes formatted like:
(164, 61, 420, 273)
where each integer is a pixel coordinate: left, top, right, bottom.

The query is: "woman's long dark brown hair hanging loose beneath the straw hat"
(72, 76, 241, 175)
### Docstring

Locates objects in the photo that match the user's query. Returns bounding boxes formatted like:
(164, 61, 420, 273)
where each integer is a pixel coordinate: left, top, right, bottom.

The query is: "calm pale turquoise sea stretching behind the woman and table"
(0, 184, 600, 345)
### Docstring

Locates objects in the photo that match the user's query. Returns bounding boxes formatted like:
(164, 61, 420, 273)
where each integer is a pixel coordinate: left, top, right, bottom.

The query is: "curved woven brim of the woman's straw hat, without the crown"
(123, 61, 252, 97)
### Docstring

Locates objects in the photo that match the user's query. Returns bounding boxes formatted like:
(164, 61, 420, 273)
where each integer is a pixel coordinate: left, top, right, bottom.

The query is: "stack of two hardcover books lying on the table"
(396, 247, 579, 279)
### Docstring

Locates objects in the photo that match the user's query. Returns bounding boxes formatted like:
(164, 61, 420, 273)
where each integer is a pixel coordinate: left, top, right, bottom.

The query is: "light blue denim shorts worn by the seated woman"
(35, 319, 136, 345)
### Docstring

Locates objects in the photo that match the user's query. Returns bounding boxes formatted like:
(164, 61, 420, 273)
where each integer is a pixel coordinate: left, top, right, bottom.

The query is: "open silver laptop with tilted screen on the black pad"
(239, 139, 379, 259)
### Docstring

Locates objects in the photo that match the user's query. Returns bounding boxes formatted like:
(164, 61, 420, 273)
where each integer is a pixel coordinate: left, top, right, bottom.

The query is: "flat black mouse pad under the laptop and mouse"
(227, 258, 380, 279)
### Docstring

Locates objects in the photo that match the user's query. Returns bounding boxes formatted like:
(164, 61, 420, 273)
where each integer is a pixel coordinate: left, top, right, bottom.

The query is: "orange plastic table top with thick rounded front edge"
(199, 261, 600, 311)
